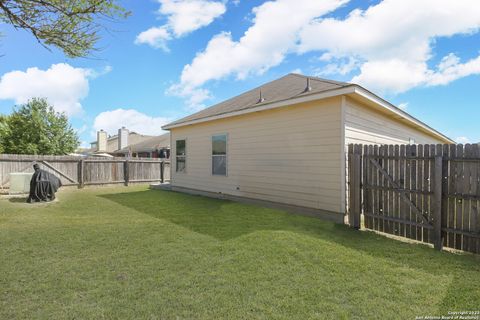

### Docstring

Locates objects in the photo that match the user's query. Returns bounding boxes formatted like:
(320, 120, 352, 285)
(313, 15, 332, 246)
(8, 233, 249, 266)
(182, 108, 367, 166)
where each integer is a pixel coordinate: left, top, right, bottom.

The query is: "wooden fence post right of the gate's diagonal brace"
(433, 153, 443, 250)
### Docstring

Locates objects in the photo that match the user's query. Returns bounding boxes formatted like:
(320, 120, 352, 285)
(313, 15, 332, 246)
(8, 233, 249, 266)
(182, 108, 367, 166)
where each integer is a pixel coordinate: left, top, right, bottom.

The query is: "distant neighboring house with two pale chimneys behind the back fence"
(89, 127, 170, 158)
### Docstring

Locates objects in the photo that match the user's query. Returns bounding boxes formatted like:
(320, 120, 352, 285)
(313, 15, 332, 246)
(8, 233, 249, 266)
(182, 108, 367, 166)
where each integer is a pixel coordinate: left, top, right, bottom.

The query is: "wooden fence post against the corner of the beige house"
(348, 144, 362, 229)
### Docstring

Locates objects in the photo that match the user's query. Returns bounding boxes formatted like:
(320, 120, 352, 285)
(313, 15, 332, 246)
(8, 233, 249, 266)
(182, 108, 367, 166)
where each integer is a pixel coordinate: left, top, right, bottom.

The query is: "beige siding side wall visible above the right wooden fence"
(344, 98, 443, 144)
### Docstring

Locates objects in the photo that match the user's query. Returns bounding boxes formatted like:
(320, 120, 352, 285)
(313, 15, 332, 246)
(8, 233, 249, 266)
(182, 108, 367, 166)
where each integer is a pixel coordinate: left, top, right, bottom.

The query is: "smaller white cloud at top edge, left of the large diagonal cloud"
(135, 0, 226, 51)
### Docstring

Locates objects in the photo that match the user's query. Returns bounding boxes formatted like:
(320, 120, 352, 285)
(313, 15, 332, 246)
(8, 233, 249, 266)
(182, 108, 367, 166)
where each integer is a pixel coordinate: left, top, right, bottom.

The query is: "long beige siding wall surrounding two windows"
(171, 98, 344, 212)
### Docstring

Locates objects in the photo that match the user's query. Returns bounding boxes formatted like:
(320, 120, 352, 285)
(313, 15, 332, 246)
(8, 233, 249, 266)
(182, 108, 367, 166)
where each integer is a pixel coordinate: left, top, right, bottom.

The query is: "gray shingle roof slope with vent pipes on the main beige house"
(163, 73, 352, 126)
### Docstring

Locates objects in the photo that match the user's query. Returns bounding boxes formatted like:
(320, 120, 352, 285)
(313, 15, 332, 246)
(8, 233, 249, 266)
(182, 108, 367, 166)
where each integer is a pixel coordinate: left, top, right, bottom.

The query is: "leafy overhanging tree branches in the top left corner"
(0, 0, 130, 58)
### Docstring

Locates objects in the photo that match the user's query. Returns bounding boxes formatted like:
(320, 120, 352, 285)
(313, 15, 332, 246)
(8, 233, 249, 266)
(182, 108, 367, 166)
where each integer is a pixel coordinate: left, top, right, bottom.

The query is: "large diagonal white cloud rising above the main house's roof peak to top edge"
(174, 0, 346, 108)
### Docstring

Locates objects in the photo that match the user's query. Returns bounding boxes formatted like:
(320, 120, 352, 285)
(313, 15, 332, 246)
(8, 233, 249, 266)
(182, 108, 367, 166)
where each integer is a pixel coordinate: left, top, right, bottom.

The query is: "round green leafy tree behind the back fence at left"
(3, 98, 79, 155)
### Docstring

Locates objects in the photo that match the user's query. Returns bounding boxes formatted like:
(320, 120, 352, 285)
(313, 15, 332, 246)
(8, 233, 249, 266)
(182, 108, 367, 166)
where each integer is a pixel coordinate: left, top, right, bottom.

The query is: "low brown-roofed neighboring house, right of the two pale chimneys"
(115, 133, 170, 158)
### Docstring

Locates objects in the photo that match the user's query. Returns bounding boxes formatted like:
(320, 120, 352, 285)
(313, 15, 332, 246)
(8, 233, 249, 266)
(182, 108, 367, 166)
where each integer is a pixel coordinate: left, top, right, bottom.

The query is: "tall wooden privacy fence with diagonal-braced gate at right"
(347, 144, 480, 253)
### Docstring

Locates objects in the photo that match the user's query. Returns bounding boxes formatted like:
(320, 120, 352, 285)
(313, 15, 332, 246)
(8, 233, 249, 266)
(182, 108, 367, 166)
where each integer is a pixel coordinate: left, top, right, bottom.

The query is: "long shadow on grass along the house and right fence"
(99, 190, 480, 314)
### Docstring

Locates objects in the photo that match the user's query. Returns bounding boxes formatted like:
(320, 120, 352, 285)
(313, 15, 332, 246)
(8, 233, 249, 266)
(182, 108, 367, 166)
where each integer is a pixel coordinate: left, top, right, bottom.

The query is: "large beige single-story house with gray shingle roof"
(163, 74, 454, 222)
